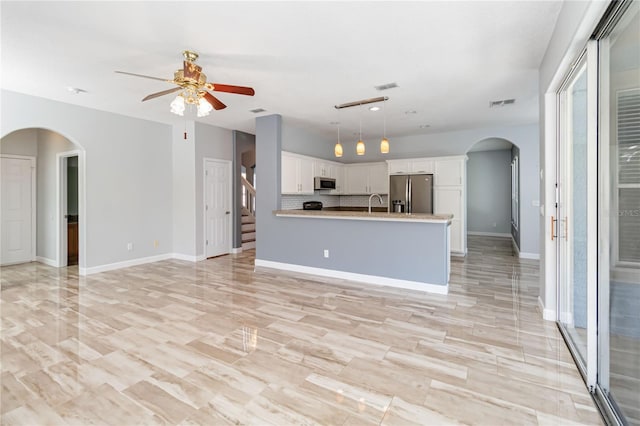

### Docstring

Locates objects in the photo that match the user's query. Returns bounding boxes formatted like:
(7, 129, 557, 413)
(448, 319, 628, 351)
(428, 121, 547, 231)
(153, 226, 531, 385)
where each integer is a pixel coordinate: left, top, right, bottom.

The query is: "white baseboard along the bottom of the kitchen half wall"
(254, 259, 449, 294)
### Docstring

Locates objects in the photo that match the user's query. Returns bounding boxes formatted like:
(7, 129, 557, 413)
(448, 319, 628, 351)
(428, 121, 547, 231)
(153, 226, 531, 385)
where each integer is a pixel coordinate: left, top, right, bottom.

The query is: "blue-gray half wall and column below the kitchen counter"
(256, 115, 446, 285)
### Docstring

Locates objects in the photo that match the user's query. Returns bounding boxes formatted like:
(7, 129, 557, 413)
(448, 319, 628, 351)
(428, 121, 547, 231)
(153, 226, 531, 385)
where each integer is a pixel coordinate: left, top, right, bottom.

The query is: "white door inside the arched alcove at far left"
(0, 157, 35, 265)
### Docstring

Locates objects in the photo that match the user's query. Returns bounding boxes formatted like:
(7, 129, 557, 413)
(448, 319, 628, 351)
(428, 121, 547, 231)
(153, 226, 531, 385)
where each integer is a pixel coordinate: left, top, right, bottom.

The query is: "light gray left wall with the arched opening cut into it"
(0, 90, 173, 267)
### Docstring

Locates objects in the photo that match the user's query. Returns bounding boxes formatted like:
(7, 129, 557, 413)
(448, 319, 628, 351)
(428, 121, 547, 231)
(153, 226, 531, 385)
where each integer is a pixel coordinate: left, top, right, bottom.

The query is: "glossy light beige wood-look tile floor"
(0, 237, 601, 425)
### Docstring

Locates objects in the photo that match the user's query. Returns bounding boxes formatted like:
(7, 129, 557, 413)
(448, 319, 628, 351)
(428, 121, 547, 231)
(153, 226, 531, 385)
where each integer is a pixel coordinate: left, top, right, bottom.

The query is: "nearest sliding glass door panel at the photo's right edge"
(597, 1, 640, 425)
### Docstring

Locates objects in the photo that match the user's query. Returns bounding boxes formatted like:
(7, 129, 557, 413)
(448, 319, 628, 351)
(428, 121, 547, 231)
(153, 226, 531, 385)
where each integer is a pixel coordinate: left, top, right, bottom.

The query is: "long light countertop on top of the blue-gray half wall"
(273, 210, 453, 224)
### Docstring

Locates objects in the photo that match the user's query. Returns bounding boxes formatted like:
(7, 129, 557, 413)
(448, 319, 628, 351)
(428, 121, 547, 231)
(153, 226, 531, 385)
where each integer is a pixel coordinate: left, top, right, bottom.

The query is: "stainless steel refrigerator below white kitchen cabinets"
(389, 174, 433, 214)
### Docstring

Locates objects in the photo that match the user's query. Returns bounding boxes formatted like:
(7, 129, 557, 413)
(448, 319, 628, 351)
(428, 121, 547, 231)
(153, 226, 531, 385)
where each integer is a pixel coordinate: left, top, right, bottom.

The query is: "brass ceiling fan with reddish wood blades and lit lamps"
(116, 50, 255, 117)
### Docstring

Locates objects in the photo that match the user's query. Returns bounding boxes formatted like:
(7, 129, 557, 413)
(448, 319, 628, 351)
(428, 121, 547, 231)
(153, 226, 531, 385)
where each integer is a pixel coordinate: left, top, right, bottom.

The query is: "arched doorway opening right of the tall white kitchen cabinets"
(466, 137, 520, 250)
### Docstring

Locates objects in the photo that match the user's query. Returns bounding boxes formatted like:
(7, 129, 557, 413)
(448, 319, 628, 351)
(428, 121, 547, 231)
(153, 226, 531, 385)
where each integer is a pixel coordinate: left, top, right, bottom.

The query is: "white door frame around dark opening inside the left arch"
(56, 149, 87, 275)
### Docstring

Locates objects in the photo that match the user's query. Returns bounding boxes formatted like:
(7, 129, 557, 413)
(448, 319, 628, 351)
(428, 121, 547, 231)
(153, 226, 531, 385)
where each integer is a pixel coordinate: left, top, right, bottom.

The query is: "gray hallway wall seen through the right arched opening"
(467, 150, 511, 235)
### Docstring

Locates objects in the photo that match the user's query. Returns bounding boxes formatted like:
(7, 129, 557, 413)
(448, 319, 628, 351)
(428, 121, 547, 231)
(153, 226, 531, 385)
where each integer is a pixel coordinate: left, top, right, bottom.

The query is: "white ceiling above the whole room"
(1, 1, 561, 137)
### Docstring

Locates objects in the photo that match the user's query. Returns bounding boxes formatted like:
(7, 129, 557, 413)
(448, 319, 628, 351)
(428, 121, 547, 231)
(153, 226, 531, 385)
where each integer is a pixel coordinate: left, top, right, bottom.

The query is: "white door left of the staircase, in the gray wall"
(204, 160, 231, 257)
